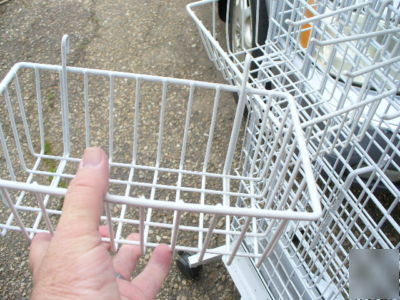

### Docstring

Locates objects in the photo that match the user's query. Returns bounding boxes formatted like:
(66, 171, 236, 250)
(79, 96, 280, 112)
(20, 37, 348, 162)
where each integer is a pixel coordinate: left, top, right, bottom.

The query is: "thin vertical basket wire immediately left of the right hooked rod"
(198, 86, 221, 248)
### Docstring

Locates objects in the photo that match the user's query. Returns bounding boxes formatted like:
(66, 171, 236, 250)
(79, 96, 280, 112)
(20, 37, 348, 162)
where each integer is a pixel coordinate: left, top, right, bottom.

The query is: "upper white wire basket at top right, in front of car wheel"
(187, 0, 400, 156)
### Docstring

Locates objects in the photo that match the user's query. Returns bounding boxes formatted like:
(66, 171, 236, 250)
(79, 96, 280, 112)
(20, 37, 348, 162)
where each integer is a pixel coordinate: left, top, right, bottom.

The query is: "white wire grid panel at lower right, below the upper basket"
(253, 122, 400, 299)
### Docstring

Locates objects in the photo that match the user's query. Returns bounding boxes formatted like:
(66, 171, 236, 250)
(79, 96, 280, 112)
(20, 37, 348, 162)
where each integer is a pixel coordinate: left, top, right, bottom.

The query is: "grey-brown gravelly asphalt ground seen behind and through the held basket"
(0, 0, 240, 300)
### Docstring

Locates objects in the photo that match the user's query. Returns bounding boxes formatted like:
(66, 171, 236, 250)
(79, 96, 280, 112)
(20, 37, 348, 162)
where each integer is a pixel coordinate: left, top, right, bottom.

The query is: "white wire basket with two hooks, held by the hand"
(0, 36, 321, 261)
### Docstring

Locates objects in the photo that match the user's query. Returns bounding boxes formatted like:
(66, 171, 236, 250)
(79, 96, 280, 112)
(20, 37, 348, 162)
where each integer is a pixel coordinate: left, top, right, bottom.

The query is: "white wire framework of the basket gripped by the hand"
(0, 36, 321, 263)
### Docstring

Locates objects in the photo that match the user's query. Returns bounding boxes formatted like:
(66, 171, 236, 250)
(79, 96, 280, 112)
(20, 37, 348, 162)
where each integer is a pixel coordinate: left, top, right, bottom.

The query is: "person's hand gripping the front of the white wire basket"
(29, 148, 172, 299)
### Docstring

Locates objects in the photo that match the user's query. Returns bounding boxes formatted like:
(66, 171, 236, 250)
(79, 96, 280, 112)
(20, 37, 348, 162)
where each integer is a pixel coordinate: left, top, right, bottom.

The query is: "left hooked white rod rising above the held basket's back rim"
(60, 34, 70, 156)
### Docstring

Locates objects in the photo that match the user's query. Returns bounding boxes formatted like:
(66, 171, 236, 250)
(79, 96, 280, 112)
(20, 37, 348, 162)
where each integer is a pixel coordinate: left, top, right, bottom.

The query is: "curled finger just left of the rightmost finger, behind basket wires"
(114, 233, 141, 279)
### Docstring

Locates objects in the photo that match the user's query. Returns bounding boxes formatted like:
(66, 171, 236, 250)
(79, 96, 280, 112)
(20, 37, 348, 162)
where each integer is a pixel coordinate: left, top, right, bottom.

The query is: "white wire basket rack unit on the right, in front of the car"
(187, 0, 400, 299)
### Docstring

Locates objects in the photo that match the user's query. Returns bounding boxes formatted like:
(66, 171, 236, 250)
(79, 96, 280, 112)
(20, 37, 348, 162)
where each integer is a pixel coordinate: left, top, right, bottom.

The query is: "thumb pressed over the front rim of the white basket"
(57, 147, 109, 237)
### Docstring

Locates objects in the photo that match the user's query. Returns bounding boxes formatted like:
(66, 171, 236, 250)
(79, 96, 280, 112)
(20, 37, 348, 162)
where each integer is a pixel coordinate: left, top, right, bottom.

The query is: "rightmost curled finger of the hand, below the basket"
(132, 244, 172, 299)
